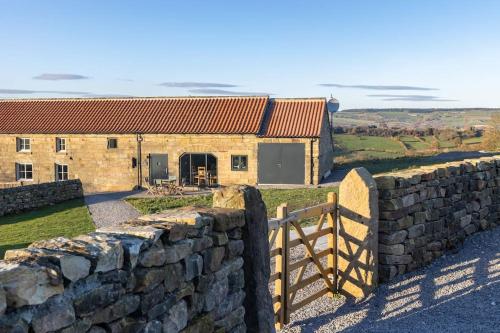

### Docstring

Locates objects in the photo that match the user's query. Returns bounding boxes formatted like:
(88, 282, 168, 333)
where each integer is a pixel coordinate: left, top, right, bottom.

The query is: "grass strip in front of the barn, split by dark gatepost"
(127, 187, 338, 217)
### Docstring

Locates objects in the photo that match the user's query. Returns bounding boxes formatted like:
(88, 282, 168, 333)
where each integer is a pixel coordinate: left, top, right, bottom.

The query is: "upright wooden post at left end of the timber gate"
(274, 203, 290, 329)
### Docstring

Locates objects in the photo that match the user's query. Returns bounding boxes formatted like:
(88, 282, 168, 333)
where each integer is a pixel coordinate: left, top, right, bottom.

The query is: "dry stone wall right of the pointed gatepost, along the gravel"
(375, 156, 500, 281)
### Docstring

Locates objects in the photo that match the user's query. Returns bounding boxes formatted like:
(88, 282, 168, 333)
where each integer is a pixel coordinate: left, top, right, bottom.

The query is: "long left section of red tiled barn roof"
(0, 97, 269, 134)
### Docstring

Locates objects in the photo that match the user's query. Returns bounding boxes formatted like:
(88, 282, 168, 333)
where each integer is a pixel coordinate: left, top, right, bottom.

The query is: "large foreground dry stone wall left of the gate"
(0, 208, 246, 333)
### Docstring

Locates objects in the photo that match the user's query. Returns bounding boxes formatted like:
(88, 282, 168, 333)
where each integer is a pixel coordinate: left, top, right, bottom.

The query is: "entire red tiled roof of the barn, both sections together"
(0, 96, 326, 137)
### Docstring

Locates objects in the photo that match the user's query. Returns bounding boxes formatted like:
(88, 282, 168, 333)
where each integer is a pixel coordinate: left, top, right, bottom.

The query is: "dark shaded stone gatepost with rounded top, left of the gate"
(213, 185, 275, 333)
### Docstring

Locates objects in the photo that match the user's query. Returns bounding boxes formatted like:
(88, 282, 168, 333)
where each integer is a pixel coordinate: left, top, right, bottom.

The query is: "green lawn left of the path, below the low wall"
(0, 199, 95, 258)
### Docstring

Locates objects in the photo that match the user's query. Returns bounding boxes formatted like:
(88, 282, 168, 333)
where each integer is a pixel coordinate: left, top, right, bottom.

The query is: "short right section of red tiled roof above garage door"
(262, 98, 326, 137)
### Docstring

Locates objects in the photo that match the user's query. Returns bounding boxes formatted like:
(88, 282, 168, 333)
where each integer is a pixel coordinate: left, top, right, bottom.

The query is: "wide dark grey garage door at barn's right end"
(258, 143, 305, 184)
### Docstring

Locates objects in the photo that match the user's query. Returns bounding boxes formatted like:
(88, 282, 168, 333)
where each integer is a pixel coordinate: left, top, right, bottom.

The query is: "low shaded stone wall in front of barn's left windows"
(0, 179, 83, 216)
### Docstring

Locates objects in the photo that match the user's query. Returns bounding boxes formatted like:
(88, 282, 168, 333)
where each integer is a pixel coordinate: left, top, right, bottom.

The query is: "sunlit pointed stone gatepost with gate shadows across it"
(337, 168, 378, 298)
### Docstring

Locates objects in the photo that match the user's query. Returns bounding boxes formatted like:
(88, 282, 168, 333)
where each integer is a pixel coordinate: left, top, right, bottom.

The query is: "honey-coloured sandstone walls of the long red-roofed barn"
(0, 134, 333, 192)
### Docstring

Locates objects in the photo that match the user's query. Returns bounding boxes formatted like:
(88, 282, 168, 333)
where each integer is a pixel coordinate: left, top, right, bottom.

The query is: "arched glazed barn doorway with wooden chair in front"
(179, 153, 218, 186)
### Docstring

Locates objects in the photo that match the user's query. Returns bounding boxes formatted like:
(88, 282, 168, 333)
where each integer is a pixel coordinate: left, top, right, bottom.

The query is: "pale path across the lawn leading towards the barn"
(85, 192, 140, 228)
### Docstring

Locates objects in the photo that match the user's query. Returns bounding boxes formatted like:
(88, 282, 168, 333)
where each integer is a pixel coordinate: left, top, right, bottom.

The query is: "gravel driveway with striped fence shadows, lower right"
(281, 227, 500, 333)
